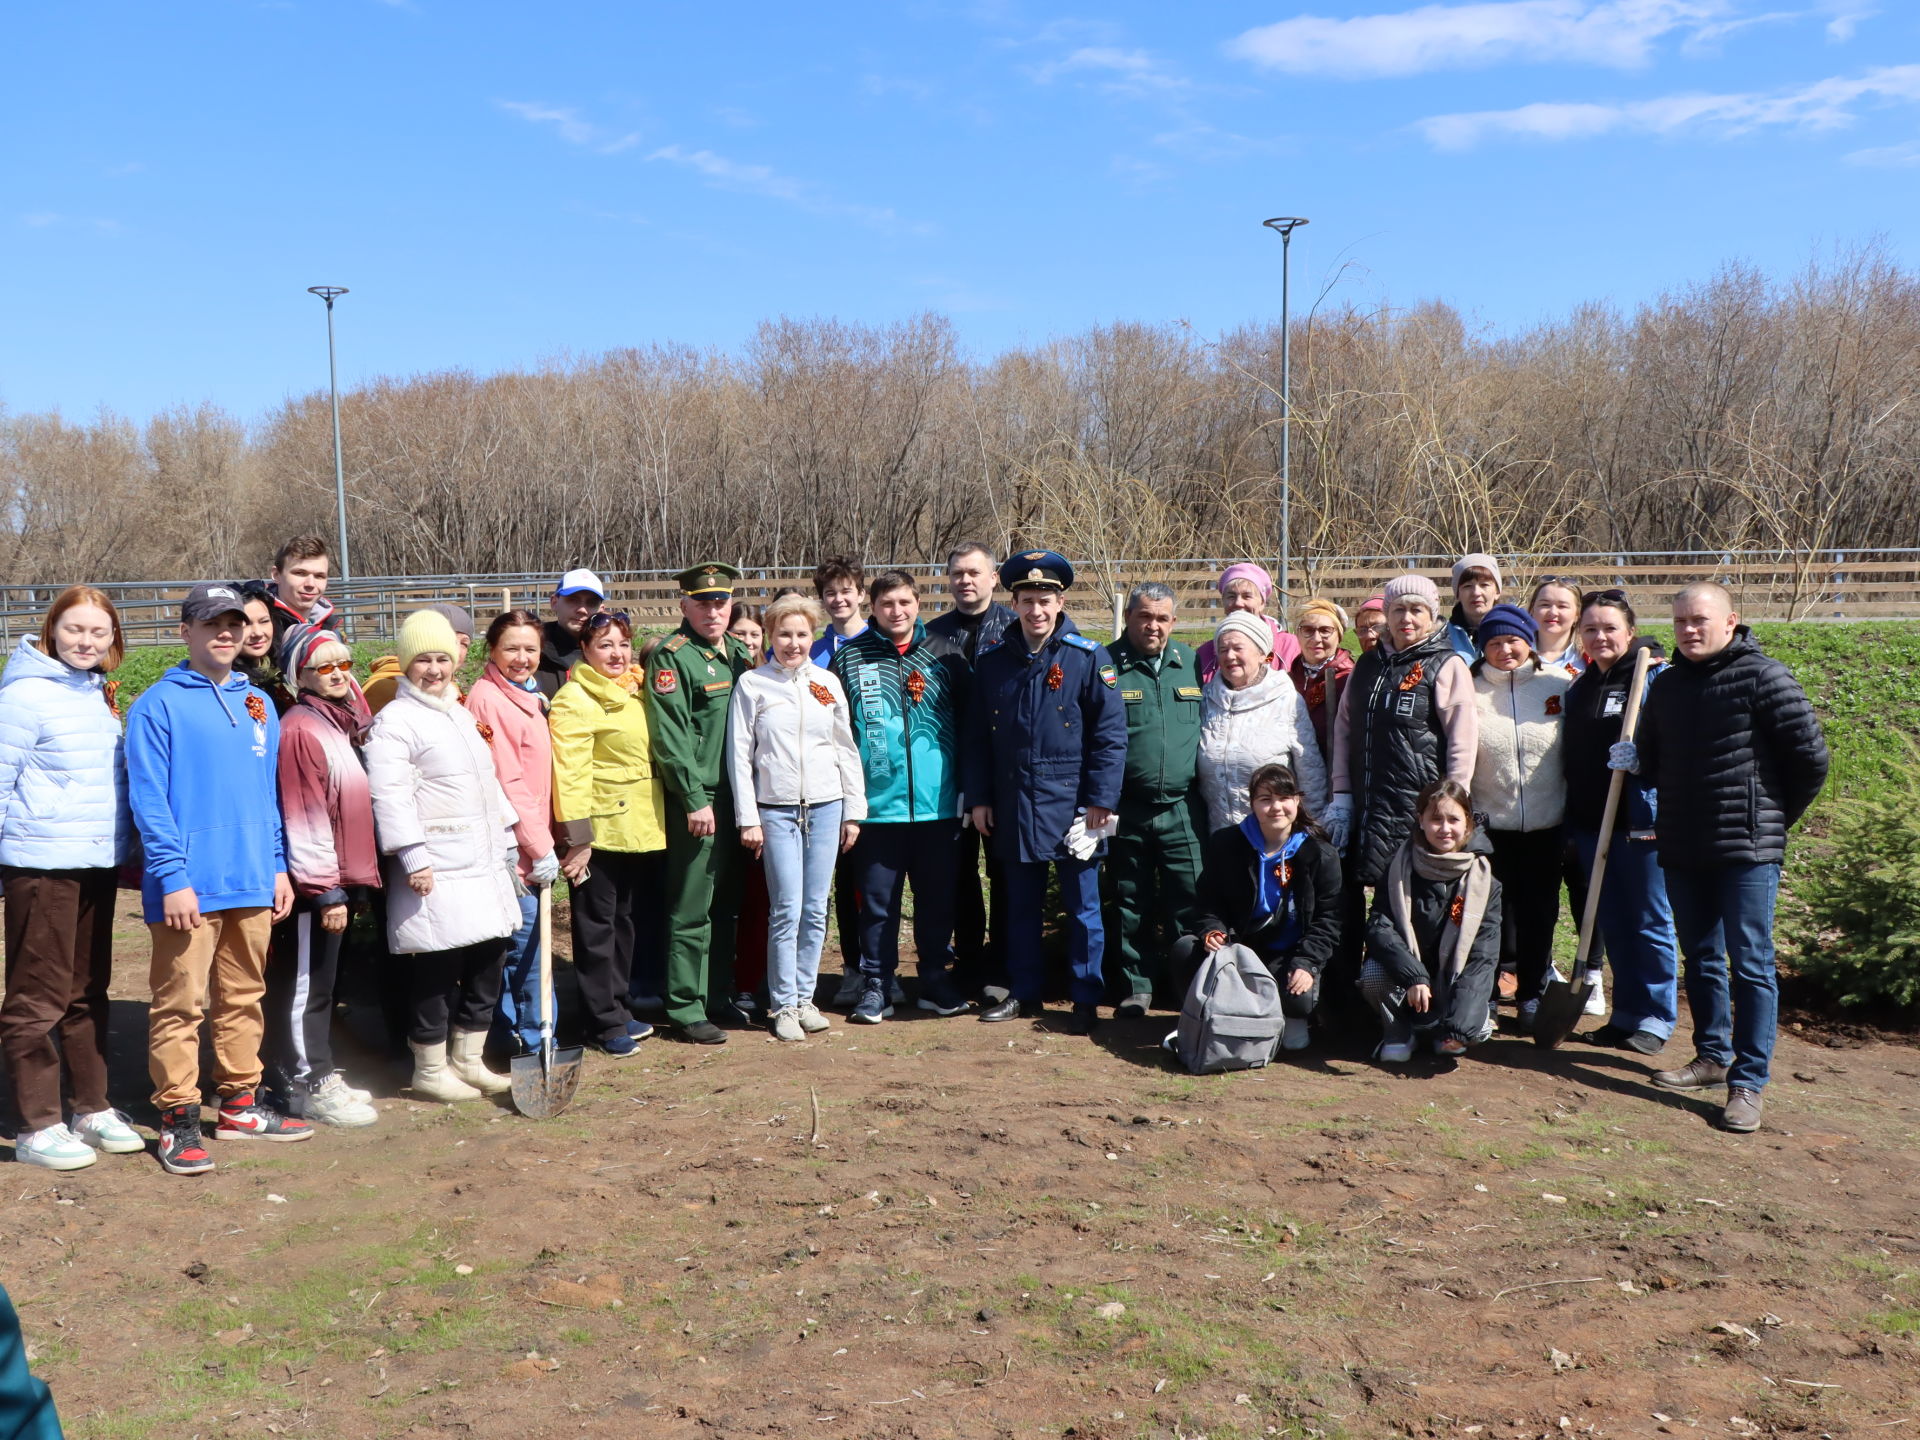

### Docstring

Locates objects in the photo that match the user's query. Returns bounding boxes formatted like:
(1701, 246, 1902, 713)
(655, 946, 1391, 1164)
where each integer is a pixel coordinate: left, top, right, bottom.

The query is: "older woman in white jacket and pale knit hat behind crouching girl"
(1200, 611, 1327, 829)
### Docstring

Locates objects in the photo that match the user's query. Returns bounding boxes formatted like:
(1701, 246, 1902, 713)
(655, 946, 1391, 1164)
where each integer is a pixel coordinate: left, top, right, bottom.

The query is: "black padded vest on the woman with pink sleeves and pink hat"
(1342, 628, 1455, 885)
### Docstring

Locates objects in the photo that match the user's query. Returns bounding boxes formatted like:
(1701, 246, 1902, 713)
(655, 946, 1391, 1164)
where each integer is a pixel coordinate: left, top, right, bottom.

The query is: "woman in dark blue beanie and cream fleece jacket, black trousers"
(1473, 605, 1572, 1025)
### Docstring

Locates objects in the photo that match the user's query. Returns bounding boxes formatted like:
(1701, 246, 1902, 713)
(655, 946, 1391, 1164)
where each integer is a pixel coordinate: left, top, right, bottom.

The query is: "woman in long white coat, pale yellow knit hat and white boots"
(367, 611, 520, 1100)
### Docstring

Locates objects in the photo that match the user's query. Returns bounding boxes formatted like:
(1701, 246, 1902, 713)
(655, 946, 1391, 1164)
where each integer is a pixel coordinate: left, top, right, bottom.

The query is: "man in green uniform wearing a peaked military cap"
(647, 563, 755, 1044)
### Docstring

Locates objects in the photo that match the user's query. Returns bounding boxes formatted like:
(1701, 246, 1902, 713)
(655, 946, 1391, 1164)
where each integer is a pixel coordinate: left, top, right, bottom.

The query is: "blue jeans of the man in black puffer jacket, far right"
(1667, 864, 1780, 1091)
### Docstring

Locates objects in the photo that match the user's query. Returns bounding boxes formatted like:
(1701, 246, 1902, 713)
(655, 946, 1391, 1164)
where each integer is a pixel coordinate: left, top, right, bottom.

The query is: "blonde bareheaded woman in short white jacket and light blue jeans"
(726, 595, 866, 1041)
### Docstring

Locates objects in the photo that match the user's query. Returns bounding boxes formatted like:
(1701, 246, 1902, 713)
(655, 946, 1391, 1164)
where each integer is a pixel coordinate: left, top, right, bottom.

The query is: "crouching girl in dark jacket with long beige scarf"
(1359, 780, 1500, 1064)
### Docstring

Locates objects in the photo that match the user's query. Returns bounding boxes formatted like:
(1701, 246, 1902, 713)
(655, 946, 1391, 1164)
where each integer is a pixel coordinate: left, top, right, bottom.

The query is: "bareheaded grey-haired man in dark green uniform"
(1106, 580, 1204, 1020)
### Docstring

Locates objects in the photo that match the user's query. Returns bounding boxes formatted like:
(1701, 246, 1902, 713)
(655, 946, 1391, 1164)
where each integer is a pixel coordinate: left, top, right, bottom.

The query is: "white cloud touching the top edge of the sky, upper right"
(1227, 0, 1732, 79)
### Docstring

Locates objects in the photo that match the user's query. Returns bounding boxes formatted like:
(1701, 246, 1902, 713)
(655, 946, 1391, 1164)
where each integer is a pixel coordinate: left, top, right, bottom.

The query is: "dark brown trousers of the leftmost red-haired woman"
(0, 866, 115, 1131)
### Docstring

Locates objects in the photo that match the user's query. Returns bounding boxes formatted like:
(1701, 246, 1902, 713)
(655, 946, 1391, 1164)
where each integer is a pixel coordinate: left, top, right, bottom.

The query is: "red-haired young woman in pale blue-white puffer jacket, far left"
(0, 586, 146, 1169)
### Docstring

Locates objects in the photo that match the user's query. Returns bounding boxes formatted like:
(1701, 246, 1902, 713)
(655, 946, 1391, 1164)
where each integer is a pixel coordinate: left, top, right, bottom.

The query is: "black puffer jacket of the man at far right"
(1636, 626, 1828, 868)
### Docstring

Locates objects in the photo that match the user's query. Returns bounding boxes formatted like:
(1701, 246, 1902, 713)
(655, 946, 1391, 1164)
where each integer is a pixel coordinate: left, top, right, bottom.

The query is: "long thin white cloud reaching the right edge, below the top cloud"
(1413, 65, 1920, 150)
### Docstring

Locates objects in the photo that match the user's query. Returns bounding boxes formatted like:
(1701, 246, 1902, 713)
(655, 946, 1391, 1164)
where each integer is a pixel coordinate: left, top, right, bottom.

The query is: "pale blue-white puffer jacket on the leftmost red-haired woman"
(0, 636, 132, 870)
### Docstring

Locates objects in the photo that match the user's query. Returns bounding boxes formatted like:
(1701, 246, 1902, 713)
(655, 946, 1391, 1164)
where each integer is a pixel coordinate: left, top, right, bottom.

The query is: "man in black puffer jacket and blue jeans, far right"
(1609, 582, 1828, 1135)
